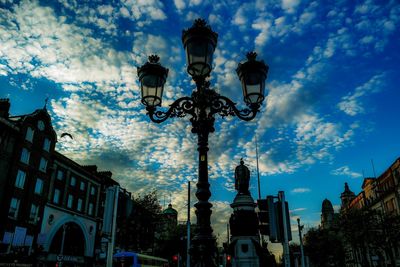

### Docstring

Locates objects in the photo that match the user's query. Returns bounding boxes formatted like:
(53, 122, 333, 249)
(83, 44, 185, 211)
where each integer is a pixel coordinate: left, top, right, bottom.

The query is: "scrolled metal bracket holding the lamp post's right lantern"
(210, 95, 260, 121)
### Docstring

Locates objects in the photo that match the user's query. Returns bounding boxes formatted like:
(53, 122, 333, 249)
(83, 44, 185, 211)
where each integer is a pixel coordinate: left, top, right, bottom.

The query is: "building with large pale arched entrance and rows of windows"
(38, 155, 111, 265)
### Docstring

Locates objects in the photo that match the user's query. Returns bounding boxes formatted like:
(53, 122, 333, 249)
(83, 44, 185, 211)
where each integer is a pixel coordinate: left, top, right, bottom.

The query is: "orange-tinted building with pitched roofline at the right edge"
(341, 158, 400, 267)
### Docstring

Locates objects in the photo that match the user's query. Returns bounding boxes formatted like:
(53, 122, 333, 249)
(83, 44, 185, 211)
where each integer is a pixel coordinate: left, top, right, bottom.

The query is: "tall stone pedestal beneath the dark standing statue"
(229, 193, 261, 267)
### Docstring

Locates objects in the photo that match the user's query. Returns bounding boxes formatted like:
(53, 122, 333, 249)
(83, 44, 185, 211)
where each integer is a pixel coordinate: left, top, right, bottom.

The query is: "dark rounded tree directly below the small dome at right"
(304, 228, 345, 267)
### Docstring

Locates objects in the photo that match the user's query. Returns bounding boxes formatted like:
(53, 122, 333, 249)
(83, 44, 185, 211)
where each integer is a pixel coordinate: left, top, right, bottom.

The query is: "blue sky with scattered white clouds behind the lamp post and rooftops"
(0, 0, 400, 255)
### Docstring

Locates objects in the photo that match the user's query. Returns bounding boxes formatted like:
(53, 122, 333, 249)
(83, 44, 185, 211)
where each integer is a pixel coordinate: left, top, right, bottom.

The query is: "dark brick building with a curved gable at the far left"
(0, 99, 57, 262)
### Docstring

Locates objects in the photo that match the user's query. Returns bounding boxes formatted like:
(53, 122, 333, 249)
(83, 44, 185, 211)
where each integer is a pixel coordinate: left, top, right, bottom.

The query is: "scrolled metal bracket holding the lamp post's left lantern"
(146, 97, 195, 123)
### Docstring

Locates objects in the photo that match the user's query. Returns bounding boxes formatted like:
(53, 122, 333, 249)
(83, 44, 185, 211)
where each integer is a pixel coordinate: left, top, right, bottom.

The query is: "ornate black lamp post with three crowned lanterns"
(138, 19, 268, 267)
